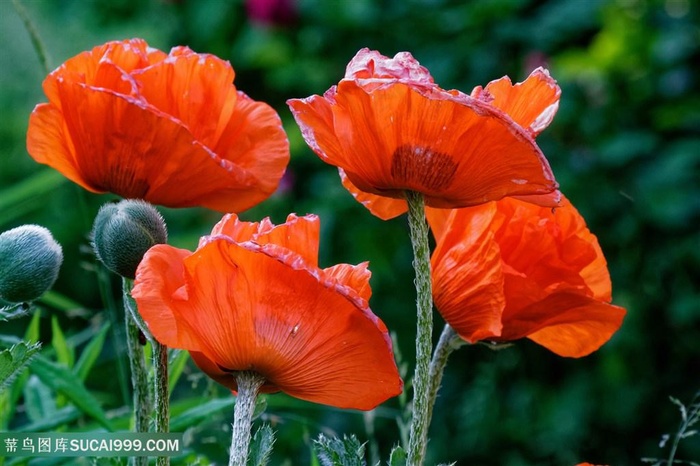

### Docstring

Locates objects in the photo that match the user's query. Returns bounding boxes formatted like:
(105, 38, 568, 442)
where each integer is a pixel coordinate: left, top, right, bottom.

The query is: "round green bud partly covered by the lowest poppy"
(92, 199, 168, 279)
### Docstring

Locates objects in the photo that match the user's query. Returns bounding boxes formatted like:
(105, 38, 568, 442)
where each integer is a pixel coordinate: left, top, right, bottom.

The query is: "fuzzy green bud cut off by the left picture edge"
(0, 225, 63, 303)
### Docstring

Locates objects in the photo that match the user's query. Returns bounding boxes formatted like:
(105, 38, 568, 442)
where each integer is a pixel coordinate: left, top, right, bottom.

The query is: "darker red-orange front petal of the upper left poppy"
(46, 83, 270, 210)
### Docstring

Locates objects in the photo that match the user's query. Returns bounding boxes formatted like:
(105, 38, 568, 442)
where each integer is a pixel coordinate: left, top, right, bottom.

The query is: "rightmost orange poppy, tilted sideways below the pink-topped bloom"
(428, 198, 625, 357)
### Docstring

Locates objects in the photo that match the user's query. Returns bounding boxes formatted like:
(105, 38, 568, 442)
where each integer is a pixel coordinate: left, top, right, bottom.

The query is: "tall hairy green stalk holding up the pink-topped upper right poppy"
(406, 191, 433, 466)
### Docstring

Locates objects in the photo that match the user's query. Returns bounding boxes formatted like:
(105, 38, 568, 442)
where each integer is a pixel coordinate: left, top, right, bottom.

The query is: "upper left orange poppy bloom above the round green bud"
(27, 39, 289, 212)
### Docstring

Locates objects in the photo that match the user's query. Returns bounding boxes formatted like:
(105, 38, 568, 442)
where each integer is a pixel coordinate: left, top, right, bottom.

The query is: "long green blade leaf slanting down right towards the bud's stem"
(30, 356, 113, 431)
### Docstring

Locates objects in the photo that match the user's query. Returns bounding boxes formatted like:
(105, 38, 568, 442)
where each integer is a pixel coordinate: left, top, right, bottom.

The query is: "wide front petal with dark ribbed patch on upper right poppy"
(307, 81, 556, 208)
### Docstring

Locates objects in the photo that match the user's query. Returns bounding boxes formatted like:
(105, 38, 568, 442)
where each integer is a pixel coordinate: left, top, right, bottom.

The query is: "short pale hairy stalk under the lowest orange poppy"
(228, 371, 265, 466)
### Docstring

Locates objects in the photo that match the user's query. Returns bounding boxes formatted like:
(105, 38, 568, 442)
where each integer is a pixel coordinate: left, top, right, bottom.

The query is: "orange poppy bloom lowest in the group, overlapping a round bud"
(132, 215, 403, 410)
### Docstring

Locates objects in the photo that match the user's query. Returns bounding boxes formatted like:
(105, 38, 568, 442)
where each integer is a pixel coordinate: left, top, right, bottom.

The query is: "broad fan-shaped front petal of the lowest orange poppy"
(139, 236, 402, 409)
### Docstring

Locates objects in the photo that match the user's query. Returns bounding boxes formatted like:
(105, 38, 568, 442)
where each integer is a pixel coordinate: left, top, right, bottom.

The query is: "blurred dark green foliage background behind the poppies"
(0, 0, 700, 466)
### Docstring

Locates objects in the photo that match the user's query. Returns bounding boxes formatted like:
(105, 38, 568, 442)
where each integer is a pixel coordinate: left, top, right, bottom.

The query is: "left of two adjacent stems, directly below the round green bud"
(122, 278, 152, 466)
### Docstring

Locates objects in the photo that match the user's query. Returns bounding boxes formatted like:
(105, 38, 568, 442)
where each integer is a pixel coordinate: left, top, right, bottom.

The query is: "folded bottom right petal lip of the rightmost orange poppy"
(501, 293, 625, 358)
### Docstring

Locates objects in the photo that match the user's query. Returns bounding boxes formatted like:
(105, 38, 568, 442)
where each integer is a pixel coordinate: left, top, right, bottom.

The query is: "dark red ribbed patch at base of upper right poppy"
(391, 145, 457, 191)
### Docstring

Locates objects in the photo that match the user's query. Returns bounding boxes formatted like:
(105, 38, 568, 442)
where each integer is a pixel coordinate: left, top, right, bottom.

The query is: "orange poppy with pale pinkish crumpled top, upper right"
(287, 49, 559, 219)
